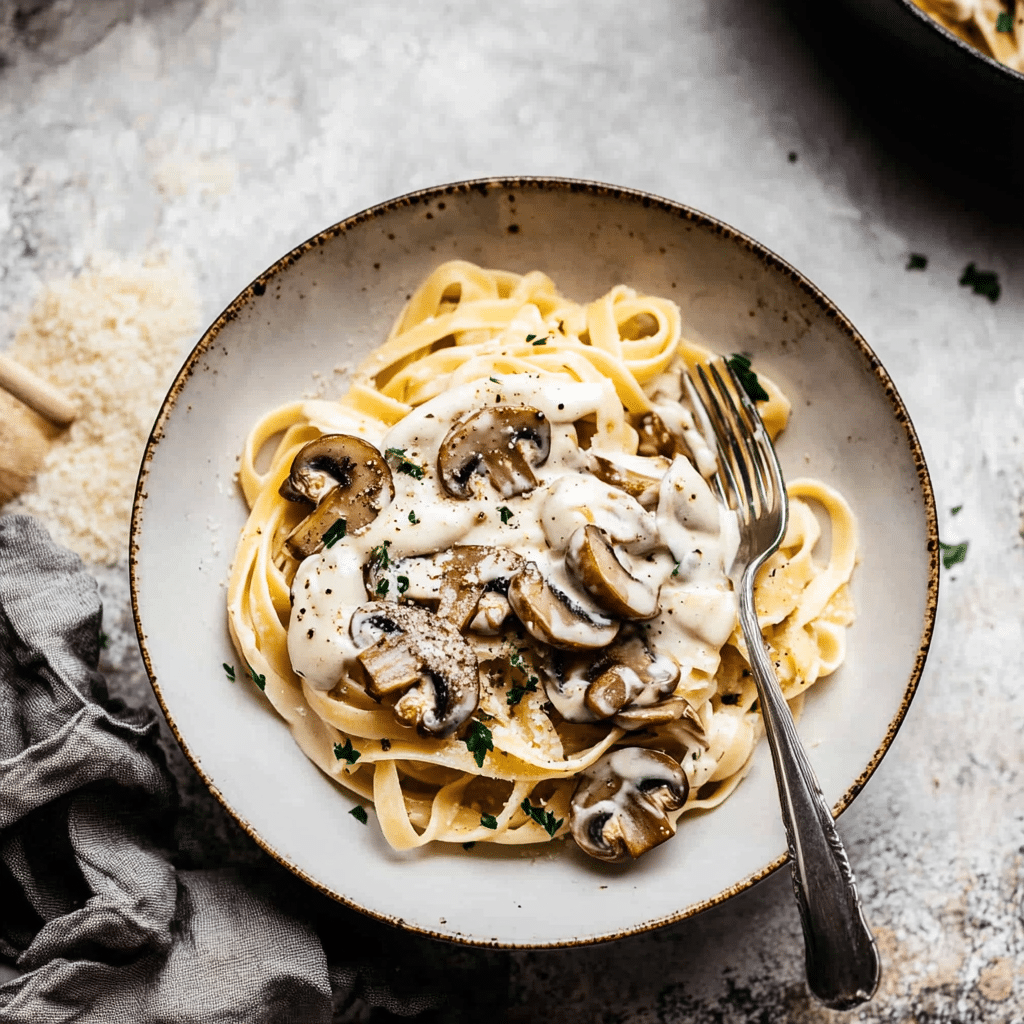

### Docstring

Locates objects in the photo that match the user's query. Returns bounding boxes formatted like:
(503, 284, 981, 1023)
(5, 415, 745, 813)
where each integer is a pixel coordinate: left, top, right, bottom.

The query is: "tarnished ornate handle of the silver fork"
(739, 577, 881, 1010)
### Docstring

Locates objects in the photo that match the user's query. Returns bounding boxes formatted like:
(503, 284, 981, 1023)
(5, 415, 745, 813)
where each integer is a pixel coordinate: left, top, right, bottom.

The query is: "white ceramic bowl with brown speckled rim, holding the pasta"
(131, 178, 938, 947)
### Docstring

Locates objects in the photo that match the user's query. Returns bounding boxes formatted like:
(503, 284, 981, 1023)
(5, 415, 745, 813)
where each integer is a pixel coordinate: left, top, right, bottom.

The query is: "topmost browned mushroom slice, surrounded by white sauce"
(437, 406, 551, 500)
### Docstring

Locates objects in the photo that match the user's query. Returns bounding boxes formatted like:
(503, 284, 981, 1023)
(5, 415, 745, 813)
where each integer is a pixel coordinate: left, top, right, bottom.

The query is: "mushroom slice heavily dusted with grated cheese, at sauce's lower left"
(349, 601, 480, 737)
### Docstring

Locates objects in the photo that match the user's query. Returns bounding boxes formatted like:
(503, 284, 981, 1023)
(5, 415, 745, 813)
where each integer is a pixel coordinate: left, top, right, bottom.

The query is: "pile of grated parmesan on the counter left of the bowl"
(2, 257, 199, 565)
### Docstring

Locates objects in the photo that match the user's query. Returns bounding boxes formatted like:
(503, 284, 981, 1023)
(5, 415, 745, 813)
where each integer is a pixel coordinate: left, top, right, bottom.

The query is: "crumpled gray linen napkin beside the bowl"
(0, 516, 503, 1024)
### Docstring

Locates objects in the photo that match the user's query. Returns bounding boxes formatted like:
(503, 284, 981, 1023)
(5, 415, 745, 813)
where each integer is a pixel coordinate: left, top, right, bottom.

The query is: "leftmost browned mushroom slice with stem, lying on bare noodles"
(280, 434, 394, 559)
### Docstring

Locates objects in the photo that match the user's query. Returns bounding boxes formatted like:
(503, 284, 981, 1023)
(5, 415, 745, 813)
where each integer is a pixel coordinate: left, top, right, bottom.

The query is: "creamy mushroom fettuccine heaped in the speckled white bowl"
(228, 261, 856, 860)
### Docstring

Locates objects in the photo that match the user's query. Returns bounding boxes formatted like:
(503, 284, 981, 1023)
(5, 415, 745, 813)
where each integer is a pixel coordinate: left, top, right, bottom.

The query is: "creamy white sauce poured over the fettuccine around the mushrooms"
(288, 375, 736, 702)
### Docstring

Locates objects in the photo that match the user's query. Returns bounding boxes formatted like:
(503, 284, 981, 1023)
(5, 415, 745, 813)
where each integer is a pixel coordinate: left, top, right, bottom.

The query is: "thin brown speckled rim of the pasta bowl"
(128, 176, 939, 949)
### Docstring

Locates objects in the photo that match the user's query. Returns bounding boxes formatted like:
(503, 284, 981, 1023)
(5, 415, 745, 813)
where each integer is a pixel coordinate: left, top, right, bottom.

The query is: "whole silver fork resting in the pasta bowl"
(683, 360, 881, 1010)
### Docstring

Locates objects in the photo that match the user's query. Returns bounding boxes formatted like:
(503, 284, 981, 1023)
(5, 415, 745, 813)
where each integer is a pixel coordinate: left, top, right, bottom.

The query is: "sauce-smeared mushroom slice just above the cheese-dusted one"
(367, 544, 526, 630)
